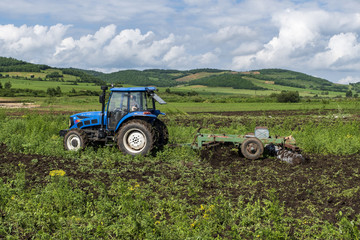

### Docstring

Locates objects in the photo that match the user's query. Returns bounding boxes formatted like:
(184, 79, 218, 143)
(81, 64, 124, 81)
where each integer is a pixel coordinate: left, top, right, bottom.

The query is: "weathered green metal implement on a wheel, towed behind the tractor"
(190, 127, 304, 163)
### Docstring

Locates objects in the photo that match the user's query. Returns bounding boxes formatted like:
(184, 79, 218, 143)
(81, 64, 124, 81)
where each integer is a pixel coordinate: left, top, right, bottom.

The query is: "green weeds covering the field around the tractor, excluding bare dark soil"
(0, 110, 360, 239)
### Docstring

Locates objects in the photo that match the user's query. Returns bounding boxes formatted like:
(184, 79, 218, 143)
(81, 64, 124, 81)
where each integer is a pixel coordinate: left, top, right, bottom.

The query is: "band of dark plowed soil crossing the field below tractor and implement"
(0, 144, 360, 223)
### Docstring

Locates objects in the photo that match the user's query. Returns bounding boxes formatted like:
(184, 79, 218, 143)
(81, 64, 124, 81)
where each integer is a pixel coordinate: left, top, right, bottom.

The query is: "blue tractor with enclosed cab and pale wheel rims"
(60, 86, 169, 155)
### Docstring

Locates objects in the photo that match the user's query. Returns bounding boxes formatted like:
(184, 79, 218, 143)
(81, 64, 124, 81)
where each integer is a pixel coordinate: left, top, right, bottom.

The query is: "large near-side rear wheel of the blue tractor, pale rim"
(117, 120, 154, 156)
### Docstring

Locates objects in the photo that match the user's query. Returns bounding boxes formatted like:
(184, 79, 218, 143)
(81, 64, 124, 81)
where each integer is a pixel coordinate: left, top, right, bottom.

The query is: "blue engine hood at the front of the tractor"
(70, 111, 101, 129)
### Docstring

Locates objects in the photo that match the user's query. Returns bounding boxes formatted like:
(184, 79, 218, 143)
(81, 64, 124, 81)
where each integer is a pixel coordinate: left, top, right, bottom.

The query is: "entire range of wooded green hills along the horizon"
(0, 57, 348, 92)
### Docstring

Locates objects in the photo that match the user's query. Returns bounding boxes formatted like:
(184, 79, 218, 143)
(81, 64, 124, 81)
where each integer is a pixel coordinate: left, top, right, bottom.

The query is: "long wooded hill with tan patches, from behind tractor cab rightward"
(91, 69, 348, 92)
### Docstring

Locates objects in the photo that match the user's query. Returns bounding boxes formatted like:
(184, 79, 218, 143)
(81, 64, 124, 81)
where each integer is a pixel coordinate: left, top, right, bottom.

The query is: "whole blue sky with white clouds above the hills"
(0, 0, 360, 84)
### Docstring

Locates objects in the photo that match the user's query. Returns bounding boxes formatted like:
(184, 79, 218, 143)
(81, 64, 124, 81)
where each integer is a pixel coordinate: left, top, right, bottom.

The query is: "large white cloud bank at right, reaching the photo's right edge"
(232, 9, 360, 75)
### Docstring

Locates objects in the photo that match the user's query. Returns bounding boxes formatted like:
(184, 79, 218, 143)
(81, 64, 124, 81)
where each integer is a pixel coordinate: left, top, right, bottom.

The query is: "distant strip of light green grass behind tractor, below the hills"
(1, 94, 360, 114)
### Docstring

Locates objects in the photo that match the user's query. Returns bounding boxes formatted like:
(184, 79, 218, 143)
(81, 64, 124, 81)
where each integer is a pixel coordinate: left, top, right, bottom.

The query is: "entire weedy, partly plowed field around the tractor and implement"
(0, 104, 360, 239)
